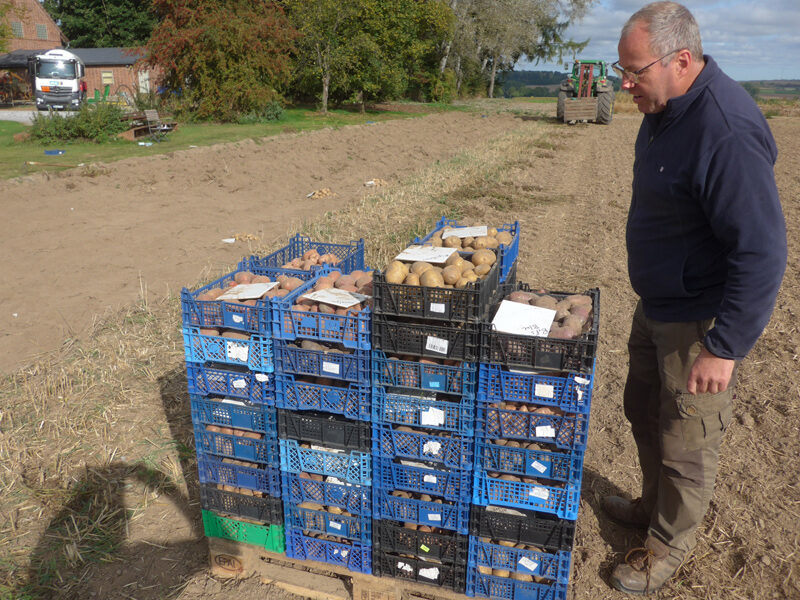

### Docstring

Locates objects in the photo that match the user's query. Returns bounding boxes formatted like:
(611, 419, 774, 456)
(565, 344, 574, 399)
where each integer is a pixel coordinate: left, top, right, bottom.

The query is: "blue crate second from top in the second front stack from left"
(273, 340, 370, 385)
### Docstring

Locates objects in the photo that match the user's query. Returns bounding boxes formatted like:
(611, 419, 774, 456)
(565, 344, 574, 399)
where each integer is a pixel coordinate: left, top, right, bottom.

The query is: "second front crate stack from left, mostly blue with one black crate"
(260, 237, 372, 573)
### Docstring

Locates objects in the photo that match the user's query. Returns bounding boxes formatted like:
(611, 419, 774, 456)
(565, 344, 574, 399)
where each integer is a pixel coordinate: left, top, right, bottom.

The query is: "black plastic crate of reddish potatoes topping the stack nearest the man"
(480, 283, 600, 373)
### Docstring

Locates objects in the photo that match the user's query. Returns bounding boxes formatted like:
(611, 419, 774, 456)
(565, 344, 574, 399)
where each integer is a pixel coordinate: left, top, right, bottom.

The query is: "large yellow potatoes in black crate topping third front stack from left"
(384, 246, 497, 289)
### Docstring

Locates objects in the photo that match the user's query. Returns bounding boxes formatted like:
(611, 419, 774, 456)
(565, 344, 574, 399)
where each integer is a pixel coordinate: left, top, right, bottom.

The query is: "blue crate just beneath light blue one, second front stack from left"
(281, 471, 372, 516)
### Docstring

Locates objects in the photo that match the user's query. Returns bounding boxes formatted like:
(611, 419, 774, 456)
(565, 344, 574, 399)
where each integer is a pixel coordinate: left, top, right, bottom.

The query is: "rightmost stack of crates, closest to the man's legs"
(467, 284, 600, 600)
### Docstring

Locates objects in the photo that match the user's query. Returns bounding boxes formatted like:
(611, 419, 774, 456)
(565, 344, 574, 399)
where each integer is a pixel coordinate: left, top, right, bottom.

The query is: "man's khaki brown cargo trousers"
(623, 300, 738, 560)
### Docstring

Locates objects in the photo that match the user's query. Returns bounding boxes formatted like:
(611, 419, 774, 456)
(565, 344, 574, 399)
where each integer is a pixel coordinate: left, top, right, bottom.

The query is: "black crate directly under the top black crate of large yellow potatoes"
(372, 315, 486, 362)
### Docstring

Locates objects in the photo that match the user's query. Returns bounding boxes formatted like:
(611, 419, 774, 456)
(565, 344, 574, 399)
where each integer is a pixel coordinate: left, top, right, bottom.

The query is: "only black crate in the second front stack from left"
(278, 408, 372, 452)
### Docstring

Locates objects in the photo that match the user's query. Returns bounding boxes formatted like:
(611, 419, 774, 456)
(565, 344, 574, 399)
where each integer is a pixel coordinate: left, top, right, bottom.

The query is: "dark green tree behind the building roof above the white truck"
(44, 0, 155, 48)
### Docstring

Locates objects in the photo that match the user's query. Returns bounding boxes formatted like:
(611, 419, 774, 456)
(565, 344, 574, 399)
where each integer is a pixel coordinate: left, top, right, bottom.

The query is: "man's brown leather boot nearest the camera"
(611, 536, 683, 595)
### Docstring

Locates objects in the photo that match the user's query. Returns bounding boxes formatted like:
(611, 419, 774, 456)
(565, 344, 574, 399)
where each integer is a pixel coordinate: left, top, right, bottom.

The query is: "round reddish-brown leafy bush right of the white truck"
(147, 0, 297, 121)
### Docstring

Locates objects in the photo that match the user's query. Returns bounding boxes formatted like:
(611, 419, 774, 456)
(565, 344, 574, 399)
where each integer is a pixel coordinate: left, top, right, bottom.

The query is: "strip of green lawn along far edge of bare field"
(0, 104, 450, 179)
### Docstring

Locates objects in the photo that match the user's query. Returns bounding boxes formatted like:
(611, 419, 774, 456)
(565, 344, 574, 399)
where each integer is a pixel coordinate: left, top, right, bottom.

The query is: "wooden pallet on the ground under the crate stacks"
(207, 538, 466, 600)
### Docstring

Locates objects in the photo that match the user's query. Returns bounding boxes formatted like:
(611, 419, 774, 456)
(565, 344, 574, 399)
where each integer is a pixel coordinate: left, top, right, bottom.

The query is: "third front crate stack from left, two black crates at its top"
(372, 219, 519, 593)
